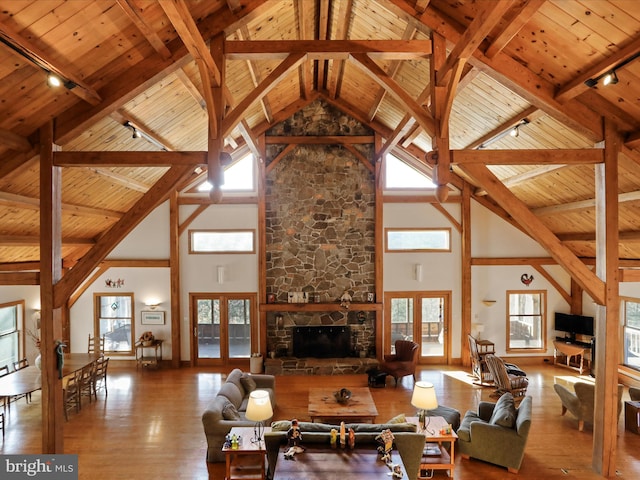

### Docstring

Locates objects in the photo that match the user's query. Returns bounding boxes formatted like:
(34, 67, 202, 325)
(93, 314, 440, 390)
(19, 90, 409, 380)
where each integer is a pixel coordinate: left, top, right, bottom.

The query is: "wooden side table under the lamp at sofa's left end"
(222, 427, 271, 480)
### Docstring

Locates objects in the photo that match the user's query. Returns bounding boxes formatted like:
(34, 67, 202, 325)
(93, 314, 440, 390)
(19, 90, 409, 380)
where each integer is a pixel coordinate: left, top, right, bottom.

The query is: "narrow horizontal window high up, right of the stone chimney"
(385, 228, 451, 252)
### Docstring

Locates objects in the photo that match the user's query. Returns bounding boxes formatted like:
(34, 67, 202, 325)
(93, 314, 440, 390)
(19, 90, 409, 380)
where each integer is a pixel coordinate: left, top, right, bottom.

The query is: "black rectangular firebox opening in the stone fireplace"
(293, 326, 351, 358)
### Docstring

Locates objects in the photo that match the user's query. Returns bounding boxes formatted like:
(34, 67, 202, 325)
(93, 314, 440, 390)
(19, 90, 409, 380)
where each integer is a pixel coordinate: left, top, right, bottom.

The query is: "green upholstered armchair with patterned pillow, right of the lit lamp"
(456, 393, 532, 473)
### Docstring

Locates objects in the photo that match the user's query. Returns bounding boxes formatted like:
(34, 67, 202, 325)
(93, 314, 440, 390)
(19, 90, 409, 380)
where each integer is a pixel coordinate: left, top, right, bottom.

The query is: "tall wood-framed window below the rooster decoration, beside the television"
(507, 290, 547, 351)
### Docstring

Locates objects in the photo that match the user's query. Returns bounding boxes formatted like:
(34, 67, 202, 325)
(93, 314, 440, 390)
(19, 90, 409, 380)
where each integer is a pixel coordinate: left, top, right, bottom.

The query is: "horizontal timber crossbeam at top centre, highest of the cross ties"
(225, 40, 431, 60)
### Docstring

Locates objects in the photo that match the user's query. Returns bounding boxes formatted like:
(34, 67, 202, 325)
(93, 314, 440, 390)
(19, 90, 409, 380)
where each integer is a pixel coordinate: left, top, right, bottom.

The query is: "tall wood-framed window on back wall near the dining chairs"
(94, 293, 134, 354)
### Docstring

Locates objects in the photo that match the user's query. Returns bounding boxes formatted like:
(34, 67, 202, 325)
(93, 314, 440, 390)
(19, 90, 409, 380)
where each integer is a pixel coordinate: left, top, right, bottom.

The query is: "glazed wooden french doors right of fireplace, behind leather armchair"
(384, 292, 451, 364)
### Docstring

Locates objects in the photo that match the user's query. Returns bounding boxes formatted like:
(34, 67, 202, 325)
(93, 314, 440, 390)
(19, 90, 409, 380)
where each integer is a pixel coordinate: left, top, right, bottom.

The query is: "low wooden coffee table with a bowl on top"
(309, 387, 378, 423)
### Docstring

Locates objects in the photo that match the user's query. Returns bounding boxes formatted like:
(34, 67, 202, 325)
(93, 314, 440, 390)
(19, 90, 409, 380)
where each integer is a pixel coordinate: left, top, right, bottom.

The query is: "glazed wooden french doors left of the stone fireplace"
(189, 293, 258, 365)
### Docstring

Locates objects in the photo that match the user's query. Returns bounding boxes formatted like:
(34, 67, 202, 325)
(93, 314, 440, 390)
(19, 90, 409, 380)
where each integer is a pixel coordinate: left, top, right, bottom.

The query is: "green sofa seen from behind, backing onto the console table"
(264, 420, 425, 480)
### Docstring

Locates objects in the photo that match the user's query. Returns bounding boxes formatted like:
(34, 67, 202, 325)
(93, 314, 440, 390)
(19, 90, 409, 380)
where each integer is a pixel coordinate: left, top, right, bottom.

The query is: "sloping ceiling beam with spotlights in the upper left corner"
(0, 19, 102, 105)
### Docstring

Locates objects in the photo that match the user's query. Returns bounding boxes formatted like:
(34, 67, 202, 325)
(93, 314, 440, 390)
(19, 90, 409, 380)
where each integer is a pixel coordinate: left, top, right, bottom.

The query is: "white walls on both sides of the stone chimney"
(0, 197, 640, 360)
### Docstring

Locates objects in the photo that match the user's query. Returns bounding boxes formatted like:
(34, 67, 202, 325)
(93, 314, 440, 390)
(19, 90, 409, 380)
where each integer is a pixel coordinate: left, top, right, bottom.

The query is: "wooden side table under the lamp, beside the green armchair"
(407, 417, 458, 479)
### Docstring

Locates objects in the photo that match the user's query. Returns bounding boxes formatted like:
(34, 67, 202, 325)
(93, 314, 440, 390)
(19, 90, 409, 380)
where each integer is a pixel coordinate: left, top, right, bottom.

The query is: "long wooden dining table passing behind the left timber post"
(0, 353, 101, 408)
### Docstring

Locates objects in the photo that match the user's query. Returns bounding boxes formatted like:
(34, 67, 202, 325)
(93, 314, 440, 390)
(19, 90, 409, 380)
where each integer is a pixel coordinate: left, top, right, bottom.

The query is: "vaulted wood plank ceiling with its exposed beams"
(0, 0, 640, 271)
